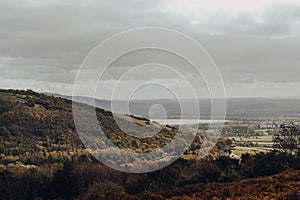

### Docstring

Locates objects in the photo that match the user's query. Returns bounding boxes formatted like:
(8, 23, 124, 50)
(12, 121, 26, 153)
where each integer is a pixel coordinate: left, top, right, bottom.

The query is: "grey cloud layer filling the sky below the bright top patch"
(0, 0, 300, 97)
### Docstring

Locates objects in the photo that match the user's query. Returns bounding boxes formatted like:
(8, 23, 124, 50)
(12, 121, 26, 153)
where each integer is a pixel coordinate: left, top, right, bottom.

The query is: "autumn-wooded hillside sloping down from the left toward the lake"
(0, 90, 189, 163)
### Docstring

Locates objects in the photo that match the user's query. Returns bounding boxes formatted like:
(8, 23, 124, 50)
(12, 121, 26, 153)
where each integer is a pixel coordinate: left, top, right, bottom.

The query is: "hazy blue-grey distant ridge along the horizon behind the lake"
(47, 94, 300, 118)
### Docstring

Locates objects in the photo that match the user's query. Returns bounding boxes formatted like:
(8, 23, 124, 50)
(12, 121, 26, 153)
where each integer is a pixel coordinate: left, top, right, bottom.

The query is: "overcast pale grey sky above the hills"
(0, 0, 300, 99)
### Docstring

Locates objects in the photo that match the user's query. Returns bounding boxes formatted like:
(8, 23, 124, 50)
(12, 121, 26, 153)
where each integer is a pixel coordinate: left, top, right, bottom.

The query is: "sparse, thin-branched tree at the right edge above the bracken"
(273, 123, 300, 160)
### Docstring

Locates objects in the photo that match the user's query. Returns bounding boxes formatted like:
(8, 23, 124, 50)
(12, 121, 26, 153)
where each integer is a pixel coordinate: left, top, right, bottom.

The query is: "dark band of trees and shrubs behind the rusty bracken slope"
(0, 152, 300, 199)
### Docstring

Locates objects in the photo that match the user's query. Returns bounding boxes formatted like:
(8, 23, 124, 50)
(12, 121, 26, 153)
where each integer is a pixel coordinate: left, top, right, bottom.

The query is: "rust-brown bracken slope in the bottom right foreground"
(170, 171, 300, 200)
